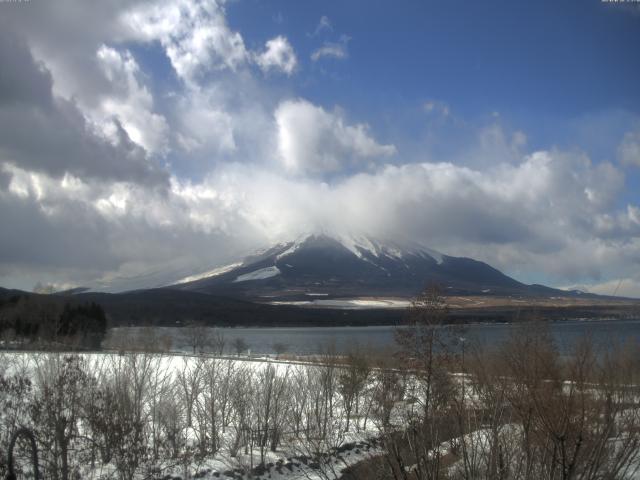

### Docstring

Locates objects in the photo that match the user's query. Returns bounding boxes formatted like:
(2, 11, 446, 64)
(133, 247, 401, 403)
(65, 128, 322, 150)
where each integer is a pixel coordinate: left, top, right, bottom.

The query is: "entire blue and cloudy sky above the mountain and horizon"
(0, 0, 640, 295)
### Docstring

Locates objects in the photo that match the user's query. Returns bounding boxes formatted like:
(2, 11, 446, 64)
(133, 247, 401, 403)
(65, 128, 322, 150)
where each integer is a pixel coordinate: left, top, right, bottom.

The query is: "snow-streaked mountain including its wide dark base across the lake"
(7, 234, 638, 326)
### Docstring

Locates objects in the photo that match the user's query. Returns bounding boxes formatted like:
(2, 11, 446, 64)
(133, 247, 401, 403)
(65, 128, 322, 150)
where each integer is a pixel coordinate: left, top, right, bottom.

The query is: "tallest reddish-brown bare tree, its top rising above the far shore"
(374, 285, 459, 480)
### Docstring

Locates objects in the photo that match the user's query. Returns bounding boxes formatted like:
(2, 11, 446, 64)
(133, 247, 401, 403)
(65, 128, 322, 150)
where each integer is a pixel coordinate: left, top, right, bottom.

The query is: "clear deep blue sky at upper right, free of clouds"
(228, 0, 640, 127)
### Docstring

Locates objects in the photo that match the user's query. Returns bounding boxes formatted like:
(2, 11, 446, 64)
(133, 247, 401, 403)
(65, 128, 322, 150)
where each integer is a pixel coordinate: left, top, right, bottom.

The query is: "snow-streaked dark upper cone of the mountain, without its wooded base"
(171, 234, 566, 300)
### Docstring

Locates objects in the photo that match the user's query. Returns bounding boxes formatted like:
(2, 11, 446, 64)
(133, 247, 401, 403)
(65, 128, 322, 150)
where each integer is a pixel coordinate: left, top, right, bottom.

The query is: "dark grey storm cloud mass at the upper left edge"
(0, 28, 168, 186)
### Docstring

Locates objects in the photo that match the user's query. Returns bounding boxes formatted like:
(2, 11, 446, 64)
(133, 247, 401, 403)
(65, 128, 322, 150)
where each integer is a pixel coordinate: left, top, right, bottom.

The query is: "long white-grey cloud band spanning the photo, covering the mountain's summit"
(0, 142, 640, 285)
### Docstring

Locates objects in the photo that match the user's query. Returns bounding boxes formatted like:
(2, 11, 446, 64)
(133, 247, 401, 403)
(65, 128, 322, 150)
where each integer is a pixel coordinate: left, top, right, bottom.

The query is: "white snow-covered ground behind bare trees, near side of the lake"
(0, 352, 382, 480)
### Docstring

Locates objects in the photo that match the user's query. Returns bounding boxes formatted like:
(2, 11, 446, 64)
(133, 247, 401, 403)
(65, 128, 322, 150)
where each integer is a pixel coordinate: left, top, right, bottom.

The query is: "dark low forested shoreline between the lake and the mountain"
(0, 288, 638, 349)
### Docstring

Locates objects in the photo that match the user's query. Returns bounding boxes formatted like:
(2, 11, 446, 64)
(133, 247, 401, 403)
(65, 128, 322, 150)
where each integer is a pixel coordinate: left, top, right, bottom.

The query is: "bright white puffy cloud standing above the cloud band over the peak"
(275, 99, 396, 173)
